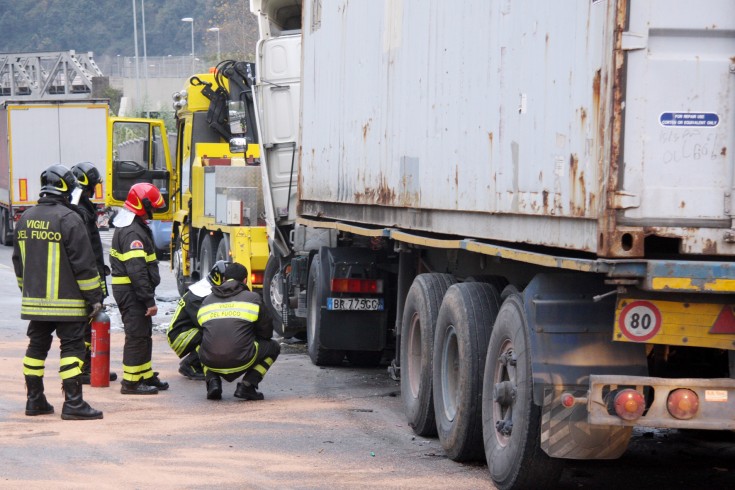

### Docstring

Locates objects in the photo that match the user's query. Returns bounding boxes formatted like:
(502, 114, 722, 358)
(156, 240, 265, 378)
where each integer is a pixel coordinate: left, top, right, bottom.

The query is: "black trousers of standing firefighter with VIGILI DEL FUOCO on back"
(23, 320, 88, 379)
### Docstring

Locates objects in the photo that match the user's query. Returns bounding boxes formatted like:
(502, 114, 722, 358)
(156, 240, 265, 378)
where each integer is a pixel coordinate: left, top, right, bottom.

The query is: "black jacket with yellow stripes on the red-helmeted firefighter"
(110, 216, 161, 308)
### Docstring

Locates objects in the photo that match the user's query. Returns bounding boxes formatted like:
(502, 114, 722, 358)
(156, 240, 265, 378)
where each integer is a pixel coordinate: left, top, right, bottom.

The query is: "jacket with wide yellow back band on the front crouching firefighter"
(197, 279, 273, 373)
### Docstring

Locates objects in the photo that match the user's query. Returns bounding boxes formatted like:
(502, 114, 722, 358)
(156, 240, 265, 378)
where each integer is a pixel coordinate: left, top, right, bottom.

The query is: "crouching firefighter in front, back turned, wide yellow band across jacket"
(197, 262, 281, 400)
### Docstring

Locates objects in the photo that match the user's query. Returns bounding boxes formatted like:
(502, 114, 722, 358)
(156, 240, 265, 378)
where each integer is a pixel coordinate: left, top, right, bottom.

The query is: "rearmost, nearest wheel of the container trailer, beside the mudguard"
(482, 294, 563, 490)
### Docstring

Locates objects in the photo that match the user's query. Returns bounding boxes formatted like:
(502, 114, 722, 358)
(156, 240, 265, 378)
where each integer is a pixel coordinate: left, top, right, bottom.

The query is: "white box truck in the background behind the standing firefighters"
(0, 100, 110, 245)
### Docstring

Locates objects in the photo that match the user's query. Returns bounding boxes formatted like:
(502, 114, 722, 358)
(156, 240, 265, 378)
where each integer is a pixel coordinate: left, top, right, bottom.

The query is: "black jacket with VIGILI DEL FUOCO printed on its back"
(13, 196, 103, 322)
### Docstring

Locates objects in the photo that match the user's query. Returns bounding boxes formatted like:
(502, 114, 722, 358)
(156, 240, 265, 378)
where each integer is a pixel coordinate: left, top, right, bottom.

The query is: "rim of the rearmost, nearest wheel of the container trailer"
(493, 339, 518, 447)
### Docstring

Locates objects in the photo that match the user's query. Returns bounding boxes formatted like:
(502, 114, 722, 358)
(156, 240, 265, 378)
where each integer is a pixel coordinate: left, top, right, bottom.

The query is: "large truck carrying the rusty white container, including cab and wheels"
(250, 0, 735, 489)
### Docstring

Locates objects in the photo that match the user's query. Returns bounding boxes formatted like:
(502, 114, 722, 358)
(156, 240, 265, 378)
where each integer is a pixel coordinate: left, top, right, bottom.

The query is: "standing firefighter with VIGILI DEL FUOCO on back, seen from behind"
(13, 164, 103, 420)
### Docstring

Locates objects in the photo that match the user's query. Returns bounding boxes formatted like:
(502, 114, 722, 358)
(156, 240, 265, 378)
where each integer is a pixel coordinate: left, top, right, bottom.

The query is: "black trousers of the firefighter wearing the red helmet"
(112, 287, 153, 382)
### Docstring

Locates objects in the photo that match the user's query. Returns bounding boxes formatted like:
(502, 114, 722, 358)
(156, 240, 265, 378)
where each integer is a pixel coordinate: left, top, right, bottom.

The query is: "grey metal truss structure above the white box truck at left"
(0, 50, 102, 102)
